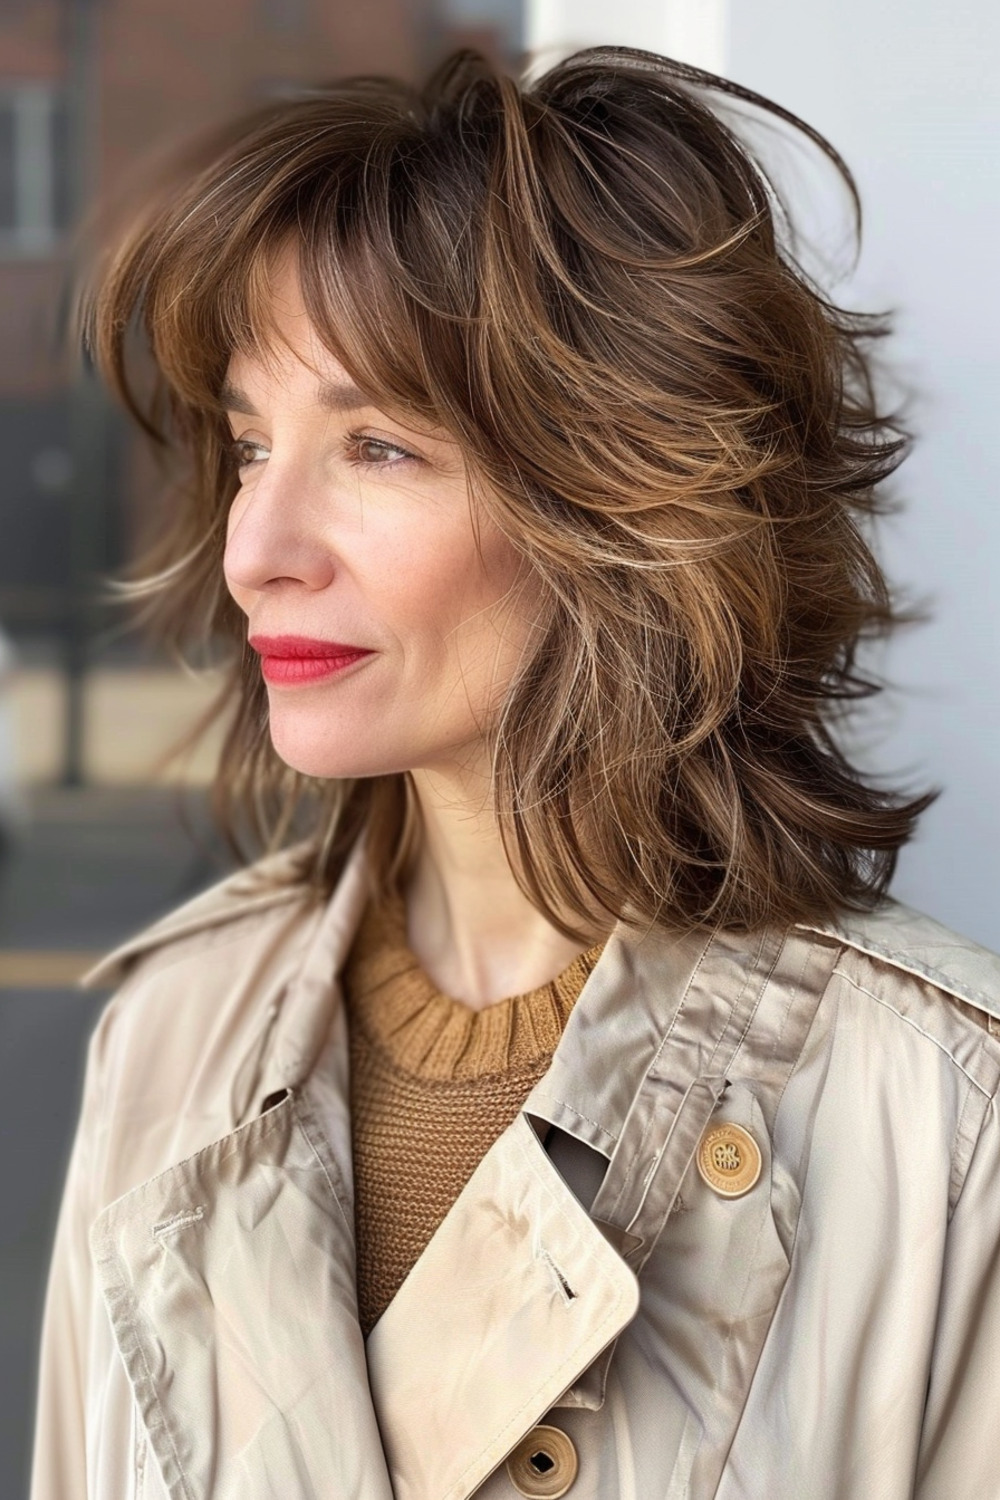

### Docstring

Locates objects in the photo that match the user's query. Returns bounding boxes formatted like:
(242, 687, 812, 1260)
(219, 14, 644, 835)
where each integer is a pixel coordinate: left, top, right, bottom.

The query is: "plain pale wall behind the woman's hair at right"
(529, 0, 1000, 950)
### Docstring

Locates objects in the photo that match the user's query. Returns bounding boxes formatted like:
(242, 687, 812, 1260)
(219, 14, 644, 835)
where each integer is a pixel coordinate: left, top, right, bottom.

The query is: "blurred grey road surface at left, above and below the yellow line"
(0, 792, 226, 1500)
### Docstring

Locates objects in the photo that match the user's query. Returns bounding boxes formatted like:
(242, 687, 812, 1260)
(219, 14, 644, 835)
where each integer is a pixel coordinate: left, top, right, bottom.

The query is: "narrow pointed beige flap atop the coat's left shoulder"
(81, 845, 321, 989)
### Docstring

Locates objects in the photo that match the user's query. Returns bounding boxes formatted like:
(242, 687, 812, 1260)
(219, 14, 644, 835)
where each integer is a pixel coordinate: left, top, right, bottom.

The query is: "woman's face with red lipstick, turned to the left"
(223, 258, 538, 777)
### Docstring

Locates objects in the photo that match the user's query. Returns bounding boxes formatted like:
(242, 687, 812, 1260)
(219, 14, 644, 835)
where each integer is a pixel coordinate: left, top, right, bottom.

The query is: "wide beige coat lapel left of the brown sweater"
(91, 1092, 391, 1500)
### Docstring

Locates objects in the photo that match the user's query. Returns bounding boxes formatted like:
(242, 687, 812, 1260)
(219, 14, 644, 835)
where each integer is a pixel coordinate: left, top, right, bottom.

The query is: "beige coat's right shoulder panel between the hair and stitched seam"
(804, 900, 1000, 1077)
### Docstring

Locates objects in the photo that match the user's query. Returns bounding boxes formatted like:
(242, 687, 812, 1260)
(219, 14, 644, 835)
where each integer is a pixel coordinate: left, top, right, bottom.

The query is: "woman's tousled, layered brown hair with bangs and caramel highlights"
(88, 48, 928, 932)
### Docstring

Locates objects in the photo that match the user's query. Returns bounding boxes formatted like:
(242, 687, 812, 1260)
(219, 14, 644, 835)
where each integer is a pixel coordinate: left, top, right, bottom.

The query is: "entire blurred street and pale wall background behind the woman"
(0, 0, 1000, 1497)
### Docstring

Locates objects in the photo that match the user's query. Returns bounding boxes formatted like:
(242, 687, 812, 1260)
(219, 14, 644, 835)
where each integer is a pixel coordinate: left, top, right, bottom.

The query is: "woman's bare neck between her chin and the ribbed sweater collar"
(406, 771, 610, 1010)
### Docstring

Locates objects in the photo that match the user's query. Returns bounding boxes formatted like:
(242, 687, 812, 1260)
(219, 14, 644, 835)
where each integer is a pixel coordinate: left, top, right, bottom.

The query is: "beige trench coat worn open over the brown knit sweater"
(31, 852, 1000, 1500)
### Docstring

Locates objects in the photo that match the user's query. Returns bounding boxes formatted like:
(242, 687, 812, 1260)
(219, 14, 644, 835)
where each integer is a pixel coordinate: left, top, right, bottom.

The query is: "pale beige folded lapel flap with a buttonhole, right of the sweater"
(367, 1115, 639, 1500)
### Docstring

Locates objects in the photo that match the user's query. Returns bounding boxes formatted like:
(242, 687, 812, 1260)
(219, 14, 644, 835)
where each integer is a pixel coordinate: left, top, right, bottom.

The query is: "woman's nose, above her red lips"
(223, 458, 336, 594)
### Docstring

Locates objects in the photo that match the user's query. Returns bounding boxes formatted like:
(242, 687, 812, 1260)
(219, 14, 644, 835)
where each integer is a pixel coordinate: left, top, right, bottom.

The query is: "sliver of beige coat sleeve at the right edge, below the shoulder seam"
(915, 1098, 1000, 1500)
